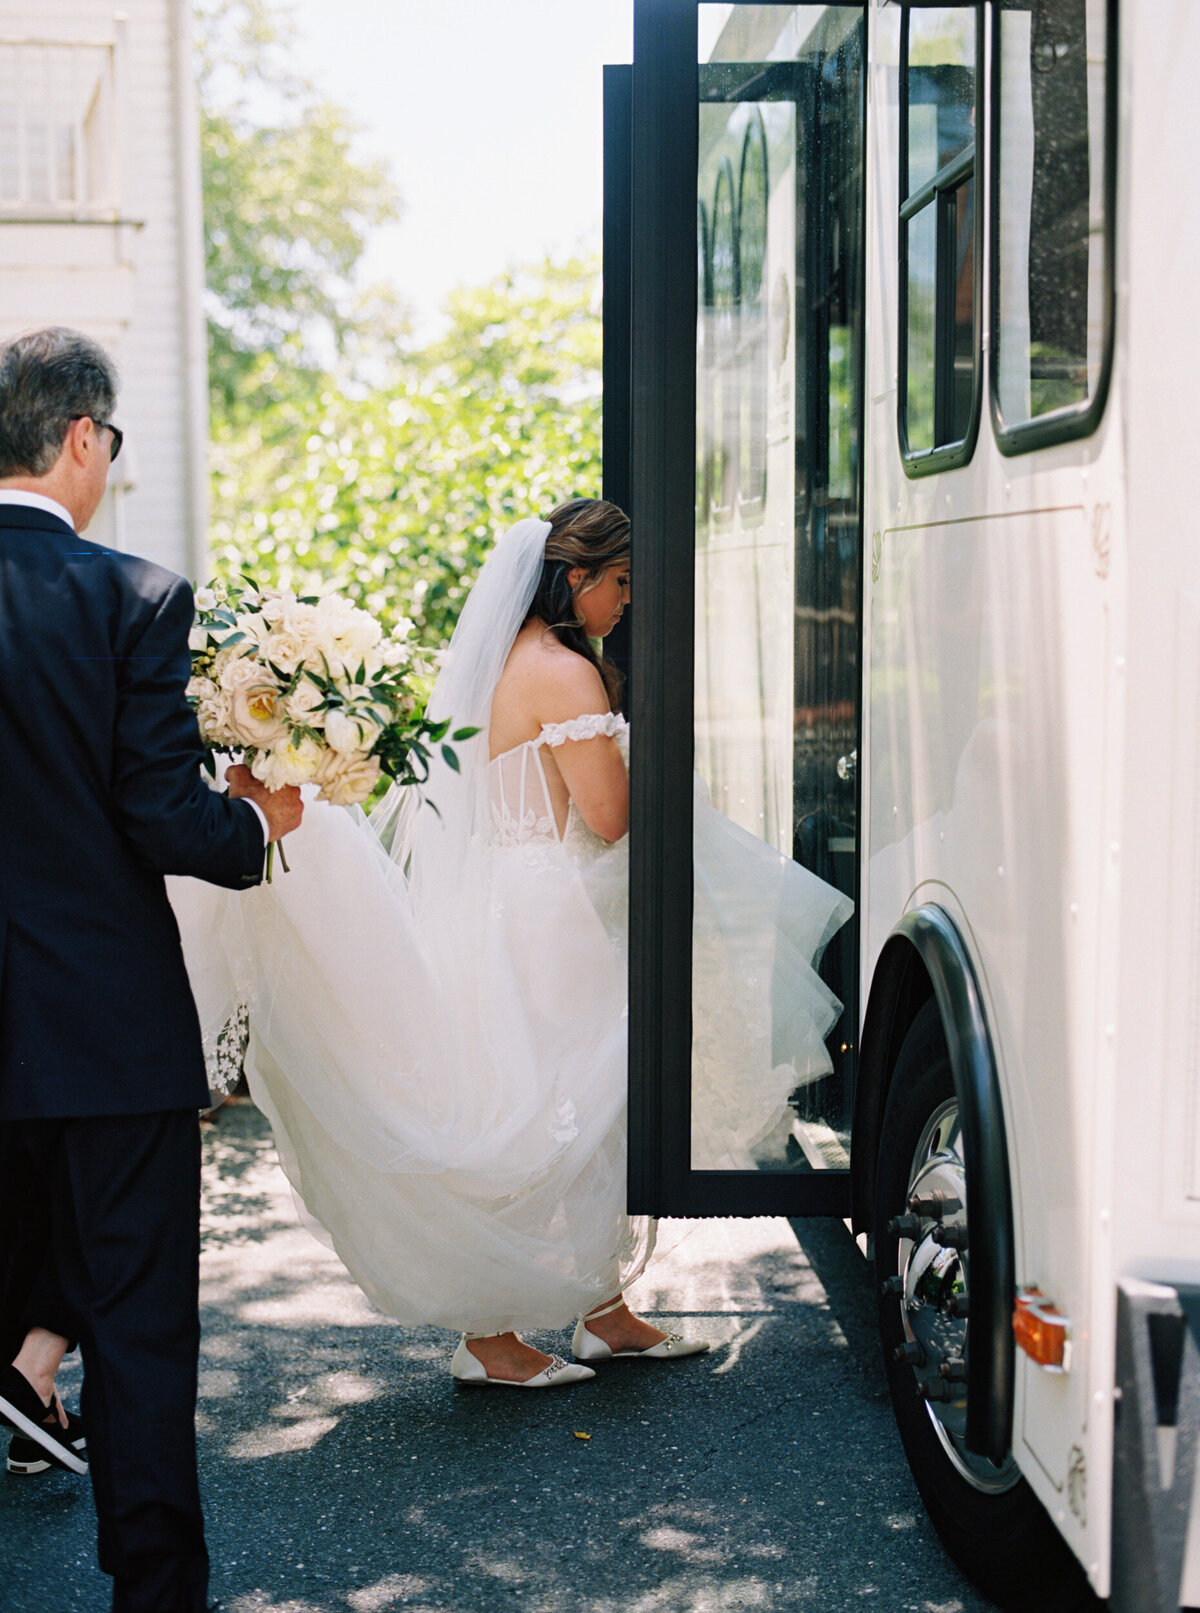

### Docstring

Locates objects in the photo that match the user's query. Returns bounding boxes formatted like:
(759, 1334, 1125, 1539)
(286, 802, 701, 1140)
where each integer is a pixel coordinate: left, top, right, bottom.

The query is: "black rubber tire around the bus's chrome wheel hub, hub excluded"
(874, 1000, 1102, 1613)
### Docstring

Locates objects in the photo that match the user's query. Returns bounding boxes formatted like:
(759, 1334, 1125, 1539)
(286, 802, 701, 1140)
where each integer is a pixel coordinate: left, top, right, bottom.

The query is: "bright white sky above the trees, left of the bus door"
(283, 0, 632, 334)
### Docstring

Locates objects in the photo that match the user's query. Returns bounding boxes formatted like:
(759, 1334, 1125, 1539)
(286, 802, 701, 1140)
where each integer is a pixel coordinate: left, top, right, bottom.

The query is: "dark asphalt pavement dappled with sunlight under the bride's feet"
(0, 1105, 992, 1613)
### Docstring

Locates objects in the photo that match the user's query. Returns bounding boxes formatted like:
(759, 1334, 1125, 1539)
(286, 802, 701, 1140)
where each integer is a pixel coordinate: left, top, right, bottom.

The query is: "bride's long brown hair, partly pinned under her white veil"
(526, 498, 631, 711)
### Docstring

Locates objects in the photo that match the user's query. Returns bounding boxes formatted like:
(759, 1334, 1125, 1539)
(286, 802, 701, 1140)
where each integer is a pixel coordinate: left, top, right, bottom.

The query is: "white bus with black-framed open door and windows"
(605, 0, 1200, 1613)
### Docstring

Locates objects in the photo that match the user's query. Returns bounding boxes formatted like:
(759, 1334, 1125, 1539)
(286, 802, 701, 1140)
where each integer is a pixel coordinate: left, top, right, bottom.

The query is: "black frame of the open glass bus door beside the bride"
(619, 0, 850, 1216)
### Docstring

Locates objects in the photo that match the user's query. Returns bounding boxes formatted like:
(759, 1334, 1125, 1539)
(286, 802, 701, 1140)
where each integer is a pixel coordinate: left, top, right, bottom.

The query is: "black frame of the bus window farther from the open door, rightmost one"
(987, 0, 1119, 458)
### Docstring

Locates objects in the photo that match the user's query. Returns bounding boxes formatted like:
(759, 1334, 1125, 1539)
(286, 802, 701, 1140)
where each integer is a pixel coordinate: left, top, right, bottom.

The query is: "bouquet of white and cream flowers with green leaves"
(187, 579, 477, 868)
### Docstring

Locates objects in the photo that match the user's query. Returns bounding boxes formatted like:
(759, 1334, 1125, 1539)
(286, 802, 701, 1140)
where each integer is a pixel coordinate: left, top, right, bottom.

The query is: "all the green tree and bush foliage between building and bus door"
(198, 0, 600, 645)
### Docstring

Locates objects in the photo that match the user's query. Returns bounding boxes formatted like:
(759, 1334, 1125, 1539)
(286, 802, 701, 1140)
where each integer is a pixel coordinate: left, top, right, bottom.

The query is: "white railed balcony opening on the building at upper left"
(0, 40, 116, 218)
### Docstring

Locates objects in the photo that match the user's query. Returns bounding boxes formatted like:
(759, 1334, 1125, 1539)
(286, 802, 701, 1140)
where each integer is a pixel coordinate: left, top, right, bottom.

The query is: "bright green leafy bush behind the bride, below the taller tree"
(213, 258, 600, 645)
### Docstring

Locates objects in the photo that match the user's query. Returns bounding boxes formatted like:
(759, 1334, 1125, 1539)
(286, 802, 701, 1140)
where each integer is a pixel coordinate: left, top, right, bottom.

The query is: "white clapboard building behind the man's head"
(0, 0, 208, 576)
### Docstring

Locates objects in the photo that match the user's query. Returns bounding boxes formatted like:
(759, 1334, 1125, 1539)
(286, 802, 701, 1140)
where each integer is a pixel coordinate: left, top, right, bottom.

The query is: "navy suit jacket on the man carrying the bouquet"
(0, 503, 263, 1121)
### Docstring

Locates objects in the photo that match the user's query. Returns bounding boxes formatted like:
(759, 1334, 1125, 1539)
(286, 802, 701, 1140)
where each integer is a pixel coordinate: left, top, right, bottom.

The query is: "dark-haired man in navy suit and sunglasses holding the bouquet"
(0, 329, 302, 1613)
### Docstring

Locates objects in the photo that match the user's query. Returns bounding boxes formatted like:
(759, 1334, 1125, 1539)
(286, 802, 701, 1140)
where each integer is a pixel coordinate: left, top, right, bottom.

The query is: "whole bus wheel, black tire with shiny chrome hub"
(874, 1000, 1098, 1613)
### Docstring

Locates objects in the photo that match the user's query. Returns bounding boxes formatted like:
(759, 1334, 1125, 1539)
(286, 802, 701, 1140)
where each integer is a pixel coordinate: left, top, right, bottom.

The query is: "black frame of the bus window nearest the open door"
(897, 0, 987, 477)
